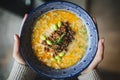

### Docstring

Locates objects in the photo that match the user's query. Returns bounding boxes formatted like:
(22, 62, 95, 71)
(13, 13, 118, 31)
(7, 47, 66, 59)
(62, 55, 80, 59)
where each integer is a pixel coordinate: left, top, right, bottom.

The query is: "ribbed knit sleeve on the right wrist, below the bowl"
(78, 69, 101, 80)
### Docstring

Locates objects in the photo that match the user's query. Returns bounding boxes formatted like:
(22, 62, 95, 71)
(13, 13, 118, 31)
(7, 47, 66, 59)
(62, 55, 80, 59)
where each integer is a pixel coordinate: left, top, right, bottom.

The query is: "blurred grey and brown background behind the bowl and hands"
(0, 0, 120, 80)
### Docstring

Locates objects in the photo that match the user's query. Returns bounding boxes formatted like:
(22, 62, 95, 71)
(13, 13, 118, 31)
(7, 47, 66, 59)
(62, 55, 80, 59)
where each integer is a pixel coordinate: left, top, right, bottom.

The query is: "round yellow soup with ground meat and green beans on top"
(31, 10, 88, 69)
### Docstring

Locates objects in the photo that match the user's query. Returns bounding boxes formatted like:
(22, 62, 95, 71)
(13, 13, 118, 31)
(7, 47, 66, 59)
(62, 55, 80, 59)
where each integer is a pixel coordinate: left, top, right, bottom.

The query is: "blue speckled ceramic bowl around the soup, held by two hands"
(20, 1, 98, 79)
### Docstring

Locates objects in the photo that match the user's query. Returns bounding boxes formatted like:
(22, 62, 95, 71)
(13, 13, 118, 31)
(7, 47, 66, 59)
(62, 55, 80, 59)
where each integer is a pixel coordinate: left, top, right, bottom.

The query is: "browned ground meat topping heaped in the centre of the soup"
(42, 22, 75, 56)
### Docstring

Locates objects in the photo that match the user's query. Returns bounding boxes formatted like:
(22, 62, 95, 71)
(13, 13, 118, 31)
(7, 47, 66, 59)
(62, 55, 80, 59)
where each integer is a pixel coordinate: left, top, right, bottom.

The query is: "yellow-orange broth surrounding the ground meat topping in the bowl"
(31, 10, 88, 69)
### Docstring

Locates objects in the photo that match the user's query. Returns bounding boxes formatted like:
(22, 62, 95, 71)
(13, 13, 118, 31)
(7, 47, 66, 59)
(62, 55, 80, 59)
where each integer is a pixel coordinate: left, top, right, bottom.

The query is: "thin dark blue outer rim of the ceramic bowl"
(20, 1, 99, 79)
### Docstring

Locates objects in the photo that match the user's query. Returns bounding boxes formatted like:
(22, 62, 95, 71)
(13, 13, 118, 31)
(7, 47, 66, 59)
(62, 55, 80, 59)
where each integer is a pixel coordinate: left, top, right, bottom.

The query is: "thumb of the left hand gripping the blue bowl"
(13, 35, 25, 64)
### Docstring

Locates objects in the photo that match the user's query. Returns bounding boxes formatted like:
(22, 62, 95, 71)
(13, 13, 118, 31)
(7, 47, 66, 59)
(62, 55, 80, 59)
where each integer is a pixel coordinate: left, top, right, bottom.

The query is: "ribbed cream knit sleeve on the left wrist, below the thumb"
(7, 61, 36, 80)
